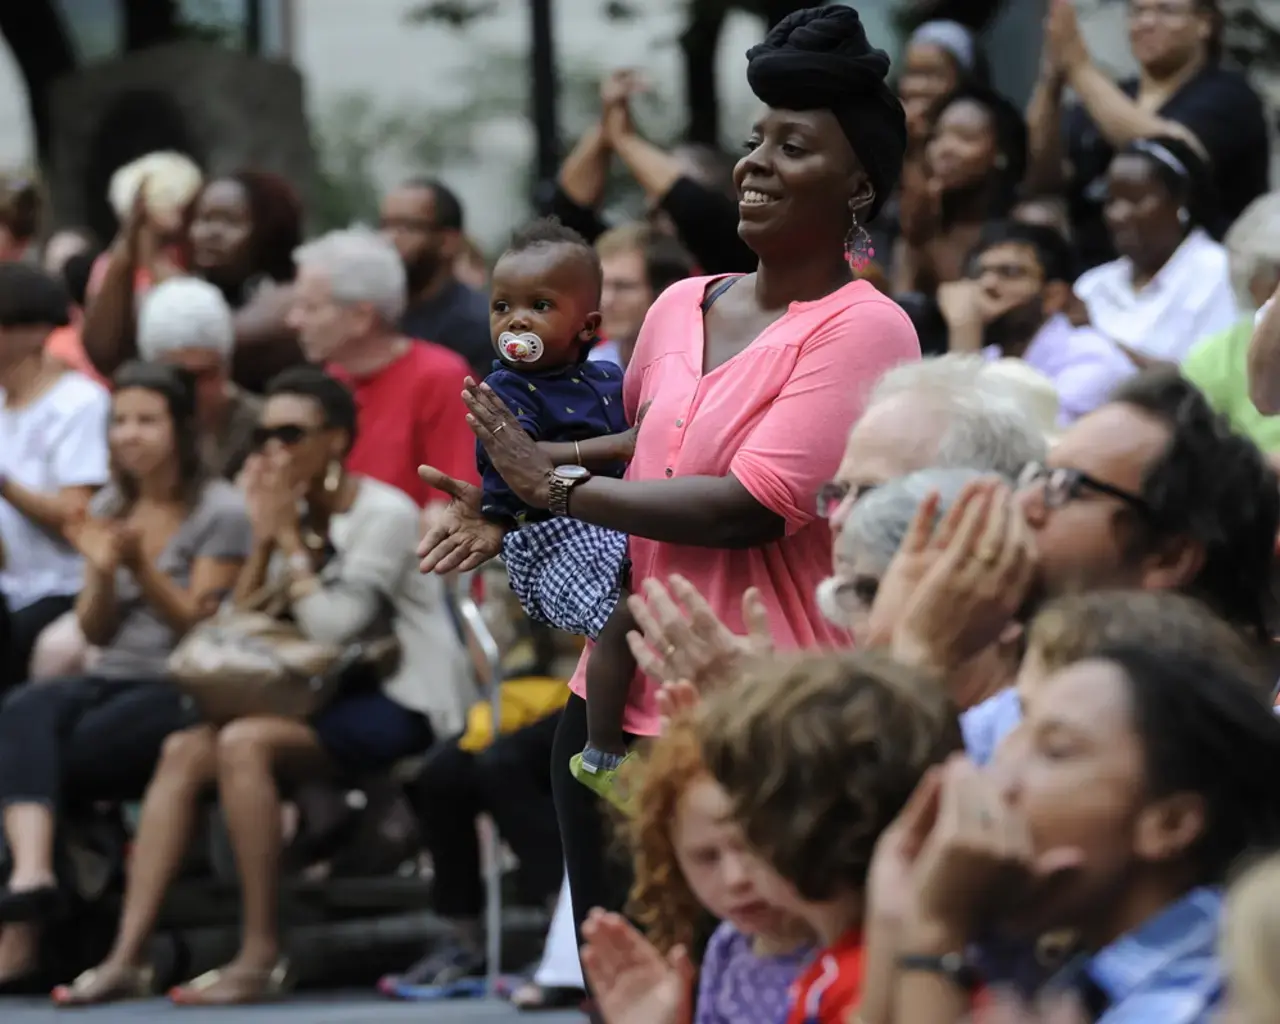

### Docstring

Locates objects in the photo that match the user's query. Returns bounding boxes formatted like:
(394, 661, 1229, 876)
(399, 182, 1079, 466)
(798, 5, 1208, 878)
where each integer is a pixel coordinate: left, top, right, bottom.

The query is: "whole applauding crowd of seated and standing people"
(0, 0, 1280, 1024)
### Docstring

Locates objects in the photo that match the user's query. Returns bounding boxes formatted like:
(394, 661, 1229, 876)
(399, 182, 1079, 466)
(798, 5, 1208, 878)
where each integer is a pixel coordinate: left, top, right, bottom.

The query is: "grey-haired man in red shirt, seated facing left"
(288, 228, 479, 508)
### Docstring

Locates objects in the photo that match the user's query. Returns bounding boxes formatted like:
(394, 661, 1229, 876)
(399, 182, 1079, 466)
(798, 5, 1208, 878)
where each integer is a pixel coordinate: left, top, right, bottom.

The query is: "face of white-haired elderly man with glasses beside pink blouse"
(820, 394, 943, 535)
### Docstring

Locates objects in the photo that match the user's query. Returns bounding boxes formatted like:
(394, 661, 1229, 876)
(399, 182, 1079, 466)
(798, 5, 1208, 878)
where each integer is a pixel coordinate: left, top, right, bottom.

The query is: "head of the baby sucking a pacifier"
(489, 243, 600, 370)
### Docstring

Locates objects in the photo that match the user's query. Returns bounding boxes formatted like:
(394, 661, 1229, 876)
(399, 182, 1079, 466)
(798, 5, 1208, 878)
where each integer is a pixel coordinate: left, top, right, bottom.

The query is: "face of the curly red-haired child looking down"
(671, 776, 788, 936)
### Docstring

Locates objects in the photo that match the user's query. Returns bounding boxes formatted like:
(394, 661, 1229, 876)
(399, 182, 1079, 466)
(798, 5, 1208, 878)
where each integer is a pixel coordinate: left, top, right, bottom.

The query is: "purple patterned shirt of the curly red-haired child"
(694, 923, 813, 1024)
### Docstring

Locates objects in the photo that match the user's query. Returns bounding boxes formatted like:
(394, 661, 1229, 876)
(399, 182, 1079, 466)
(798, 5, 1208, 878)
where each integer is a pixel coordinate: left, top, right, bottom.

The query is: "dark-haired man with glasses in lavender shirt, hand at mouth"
(938, 221, 1135, 426)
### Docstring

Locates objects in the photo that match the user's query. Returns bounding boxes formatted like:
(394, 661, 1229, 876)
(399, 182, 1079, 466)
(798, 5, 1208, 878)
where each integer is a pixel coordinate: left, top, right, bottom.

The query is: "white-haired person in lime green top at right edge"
(1181, 192, 1280, 452)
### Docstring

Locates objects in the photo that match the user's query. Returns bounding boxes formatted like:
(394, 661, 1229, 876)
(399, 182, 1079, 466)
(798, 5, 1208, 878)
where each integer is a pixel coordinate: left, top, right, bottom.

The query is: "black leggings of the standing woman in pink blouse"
(552, 695, 636, 945)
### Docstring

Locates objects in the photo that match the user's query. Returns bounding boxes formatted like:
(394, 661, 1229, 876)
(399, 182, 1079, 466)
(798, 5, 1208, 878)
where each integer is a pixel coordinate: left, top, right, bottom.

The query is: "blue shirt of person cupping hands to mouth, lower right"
(1051, 887, 1225, 1024)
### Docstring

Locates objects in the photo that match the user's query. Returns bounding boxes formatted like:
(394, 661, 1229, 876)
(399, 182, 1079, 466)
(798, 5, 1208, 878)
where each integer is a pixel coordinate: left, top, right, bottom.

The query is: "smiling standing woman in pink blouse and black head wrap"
(420, 6, 919, 998)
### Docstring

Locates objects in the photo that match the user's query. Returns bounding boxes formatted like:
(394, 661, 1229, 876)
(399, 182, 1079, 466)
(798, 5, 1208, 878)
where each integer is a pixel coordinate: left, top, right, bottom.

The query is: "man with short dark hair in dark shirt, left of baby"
(380, 178, 494, 379)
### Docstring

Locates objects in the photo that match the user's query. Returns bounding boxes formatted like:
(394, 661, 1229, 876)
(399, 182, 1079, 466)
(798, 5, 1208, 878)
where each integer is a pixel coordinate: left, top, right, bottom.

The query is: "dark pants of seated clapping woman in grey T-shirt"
(0, 676, 192, 808)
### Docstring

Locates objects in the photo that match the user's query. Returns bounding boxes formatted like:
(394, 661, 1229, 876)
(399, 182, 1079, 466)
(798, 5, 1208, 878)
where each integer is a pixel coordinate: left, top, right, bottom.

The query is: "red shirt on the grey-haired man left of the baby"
(329, 340, 480, 506)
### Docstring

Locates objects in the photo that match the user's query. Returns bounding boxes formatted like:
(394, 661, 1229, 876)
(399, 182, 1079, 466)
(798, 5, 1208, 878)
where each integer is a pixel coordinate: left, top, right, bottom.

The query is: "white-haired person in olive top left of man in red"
(137, 276, 262, 479)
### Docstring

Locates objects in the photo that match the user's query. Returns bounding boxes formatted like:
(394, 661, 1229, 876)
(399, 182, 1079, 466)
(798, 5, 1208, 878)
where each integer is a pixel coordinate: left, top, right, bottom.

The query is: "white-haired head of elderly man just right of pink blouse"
(818, 356, 1047, 534)
